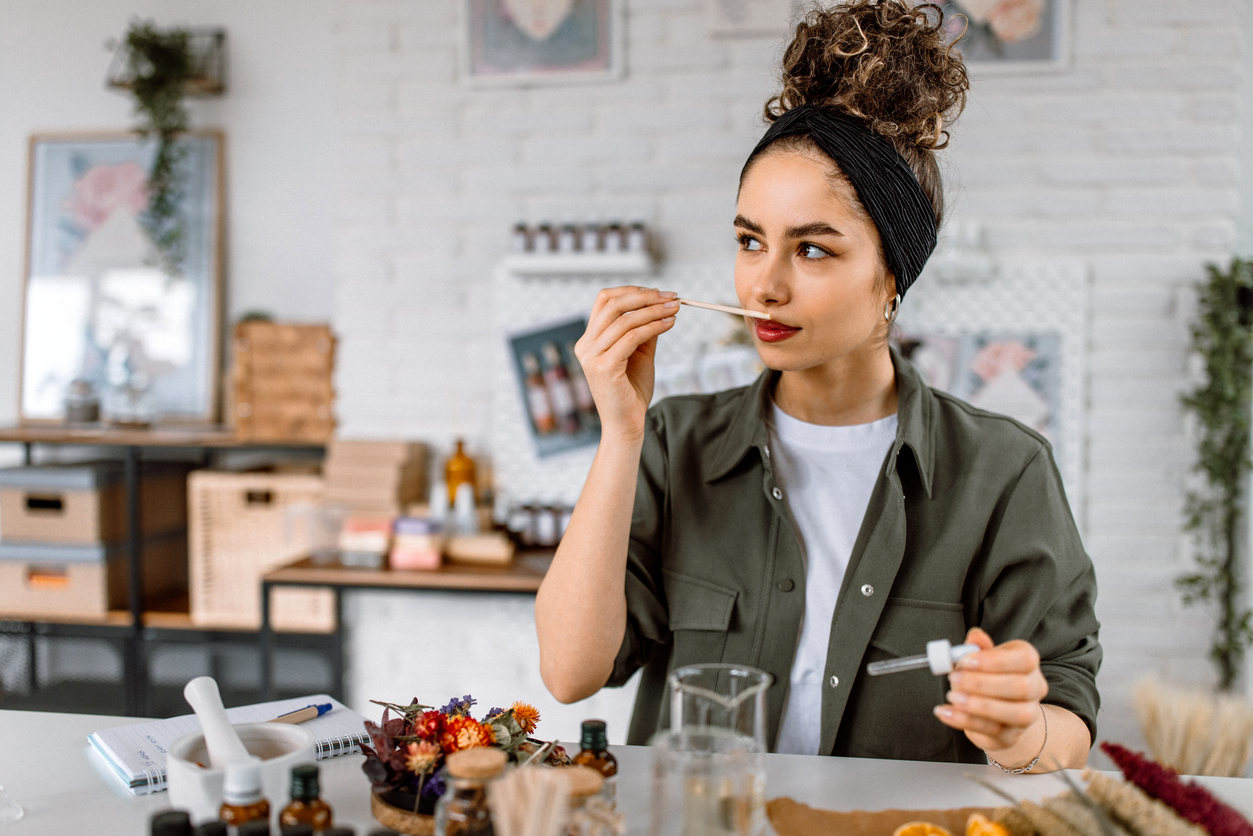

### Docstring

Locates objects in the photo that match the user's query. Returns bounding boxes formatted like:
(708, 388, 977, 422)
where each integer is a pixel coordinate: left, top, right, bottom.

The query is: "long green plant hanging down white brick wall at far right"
(1175, 258, 1253, 691)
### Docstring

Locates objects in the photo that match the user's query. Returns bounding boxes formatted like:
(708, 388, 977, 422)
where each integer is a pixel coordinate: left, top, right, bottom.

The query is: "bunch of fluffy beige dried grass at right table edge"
(1135, 678, 1253, 777)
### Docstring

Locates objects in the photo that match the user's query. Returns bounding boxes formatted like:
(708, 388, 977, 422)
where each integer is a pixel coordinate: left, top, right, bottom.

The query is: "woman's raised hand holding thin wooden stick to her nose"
(574, 287, 679, 437)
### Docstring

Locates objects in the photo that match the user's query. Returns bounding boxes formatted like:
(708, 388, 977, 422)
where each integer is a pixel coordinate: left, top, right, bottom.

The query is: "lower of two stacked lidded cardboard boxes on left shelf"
(0, 534, 187, 617)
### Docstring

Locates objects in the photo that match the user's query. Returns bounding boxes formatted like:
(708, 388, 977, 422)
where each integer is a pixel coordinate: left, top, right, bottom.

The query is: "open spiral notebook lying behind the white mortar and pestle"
(88, 694, 370, 796)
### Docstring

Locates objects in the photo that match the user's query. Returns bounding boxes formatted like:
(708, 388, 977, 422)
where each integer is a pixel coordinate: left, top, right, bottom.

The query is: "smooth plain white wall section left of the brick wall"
(0, 0, 338, 425)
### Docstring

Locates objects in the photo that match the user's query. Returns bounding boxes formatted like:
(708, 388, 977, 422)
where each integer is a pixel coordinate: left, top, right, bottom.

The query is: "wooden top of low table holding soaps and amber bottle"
(263, 551, 553, 592)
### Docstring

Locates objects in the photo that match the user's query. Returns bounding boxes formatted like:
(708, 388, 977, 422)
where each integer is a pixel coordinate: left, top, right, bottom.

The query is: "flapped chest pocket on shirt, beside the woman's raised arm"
(662, 569, 739, 669)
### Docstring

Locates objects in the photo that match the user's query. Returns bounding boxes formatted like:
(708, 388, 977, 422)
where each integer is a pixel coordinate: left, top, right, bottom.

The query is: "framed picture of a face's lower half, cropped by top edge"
(462, 0, 623, 85)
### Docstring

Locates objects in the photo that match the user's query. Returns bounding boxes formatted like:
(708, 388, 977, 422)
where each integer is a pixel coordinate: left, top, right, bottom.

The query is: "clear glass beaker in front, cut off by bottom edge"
(649, 726, 766, 836)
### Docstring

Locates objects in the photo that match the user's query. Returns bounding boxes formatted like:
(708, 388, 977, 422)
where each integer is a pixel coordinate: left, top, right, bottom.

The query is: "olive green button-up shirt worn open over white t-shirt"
(609, 351, 1101, 763)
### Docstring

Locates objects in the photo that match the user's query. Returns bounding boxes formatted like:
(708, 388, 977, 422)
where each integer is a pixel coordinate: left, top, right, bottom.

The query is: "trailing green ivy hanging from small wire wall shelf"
(119, 21, 194, 276)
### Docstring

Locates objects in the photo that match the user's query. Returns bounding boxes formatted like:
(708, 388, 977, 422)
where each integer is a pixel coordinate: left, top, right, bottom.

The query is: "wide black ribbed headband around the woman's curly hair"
(741, 104, 937, 296)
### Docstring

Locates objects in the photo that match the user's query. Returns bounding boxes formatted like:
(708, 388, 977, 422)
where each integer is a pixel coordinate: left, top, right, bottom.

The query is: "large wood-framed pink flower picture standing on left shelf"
(19, 133, 223, 424)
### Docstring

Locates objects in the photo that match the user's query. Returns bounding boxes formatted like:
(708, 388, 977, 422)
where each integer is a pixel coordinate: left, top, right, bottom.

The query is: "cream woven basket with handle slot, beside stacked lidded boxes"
(188, 470, 336, 633)
